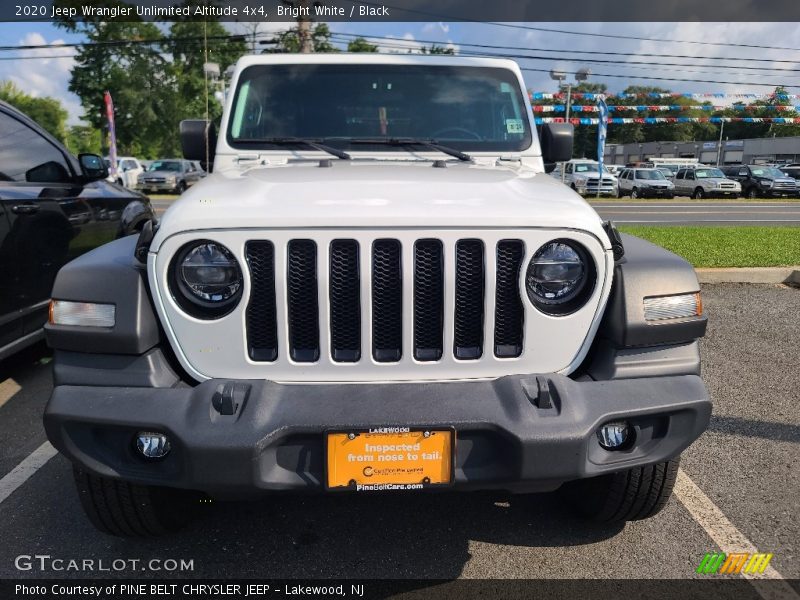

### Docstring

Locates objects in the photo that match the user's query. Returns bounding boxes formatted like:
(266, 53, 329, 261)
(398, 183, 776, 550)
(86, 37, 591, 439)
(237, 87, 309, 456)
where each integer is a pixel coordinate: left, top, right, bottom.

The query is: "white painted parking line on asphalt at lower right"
(675, 469, 800, 600)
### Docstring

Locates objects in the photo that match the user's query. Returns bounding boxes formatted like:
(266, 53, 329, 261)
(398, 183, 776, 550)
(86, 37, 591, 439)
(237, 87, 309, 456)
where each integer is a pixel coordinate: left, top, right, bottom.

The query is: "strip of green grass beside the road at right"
(619, 225, 800, 267)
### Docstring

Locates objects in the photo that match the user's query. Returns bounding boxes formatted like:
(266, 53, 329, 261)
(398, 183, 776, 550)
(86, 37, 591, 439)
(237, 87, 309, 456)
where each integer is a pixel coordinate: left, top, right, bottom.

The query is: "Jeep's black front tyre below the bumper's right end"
(561, 457, 680, 523)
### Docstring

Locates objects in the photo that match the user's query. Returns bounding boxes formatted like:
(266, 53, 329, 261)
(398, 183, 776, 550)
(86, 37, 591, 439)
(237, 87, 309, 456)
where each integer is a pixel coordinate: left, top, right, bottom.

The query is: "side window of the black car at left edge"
(0, 112, 72, 183)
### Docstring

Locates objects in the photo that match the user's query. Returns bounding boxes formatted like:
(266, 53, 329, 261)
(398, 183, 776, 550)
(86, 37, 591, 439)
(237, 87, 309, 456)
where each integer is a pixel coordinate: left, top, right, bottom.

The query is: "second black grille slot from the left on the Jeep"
(286, 240, 319, 362)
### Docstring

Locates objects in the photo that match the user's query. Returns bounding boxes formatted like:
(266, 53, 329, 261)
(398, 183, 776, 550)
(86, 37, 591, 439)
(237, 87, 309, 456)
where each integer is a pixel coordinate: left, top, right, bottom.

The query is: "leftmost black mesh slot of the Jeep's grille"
(245, 241, 278, 362)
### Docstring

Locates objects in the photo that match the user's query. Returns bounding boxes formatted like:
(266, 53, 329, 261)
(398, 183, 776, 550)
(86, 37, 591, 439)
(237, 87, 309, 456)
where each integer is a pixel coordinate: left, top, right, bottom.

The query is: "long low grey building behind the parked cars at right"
(603, 136, 800, 165)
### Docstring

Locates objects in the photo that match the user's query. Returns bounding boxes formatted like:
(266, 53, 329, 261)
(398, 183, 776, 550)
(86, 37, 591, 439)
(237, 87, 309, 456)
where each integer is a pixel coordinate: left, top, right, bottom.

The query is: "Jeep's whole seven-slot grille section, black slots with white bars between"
(245, 237, 542, 364)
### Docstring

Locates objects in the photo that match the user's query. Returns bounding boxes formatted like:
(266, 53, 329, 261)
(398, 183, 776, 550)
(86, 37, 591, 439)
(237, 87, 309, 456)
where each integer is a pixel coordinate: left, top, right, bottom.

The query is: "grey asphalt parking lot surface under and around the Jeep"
(0, 284, 800, 597)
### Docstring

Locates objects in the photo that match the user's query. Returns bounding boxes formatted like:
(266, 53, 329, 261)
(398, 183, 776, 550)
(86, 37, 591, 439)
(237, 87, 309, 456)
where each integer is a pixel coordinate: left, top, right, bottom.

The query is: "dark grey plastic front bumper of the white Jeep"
(44, 374, 711, 496)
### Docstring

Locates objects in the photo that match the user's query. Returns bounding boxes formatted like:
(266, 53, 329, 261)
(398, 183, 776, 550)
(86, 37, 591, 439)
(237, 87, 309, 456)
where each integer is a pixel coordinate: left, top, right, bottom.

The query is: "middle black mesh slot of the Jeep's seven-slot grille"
(372, 239, 403, 362)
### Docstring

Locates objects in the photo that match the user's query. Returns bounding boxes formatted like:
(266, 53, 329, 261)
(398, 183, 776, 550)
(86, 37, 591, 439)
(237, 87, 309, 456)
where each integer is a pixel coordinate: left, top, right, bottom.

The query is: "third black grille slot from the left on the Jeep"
(329, 240, 361, 362)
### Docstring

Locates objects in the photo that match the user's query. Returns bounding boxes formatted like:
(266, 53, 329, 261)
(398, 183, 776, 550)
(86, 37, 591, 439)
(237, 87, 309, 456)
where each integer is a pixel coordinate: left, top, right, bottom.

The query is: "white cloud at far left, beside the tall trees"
(0, 32, 82, 124)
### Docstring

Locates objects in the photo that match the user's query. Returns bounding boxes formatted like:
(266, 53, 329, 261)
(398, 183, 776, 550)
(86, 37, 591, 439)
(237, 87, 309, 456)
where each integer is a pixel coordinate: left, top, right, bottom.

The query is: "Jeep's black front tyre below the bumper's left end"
(73, 467, 203, 537)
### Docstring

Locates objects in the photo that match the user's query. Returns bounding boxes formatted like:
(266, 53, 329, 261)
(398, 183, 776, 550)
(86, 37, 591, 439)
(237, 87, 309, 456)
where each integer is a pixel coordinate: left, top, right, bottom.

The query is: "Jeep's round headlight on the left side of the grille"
(170, 240, 243, 319)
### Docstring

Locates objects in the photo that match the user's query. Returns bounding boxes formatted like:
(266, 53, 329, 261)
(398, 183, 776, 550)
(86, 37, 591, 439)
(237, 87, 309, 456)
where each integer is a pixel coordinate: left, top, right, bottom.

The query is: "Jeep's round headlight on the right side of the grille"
(525, 240, 595, 315)
